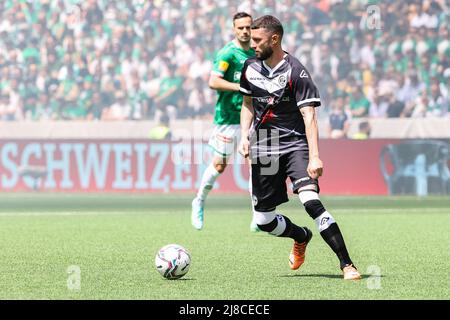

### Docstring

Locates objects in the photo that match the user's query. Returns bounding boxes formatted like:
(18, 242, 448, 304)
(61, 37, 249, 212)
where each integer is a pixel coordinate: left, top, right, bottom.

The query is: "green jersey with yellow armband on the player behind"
(211, 41, 255, 124)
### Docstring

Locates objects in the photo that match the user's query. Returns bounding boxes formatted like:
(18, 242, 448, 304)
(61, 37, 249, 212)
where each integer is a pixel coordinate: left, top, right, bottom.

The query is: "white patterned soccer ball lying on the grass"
(155, 244, 191, 280)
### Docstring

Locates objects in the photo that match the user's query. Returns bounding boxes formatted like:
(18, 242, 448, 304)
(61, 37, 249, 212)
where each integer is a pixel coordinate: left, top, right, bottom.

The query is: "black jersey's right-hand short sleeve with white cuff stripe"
(292, 68, 320, 108)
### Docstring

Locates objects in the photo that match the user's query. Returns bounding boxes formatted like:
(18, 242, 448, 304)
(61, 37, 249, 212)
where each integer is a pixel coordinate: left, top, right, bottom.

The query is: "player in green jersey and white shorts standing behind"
(191, 12, 258, 231)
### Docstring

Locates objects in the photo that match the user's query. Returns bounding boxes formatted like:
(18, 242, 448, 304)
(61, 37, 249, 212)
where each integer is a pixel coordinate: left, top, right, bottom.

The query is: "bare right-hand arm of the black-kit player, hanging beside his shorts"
(300, 106, 323, 179)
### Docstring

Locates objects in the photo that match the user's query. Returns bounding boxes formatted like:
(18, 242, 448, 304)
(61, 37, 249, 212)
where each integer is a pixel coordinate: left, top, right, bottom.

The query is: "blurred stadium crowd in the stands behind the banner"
(0, 0, 450, 124)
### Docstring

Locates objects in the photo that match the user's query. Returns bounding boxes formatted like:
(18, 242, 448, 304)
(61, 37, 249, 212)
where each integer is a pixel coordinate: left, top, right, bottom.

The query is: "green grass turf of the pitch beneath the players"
(0, 193, 450, 300)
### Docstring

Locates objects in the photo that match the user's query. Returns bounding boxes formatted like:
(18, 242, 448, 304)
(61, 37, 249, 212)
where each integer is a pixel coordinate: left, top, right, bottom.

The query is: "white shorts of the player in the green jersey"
(208, 124, 241, 157)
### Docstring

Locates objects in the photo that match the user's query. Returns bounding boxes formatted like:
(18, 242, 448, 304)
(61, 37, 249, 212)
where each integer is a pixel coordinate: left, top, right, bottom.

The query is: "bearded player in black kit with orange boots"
(239, 15, 361, 280)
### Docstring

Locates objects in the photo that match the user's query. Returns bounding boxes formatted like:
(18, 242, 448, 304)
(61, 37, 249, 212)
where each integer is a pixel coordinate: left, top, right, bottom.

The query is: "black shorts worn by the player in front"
(252, 150, 320, 212)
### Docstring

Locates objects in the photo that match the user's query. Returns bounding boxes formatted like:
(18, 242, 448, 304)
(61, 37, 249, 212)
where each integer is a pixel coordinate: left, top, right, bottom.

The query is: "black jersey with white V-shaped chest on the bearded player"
(240, 53, 320, 155)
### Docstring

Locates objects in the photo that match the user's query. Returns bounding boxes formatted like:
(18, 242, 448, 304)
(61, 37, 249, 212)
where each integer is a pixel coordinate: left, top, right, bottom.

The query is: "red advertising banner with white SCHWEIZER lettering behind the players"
(0, 139, 450, 195)
